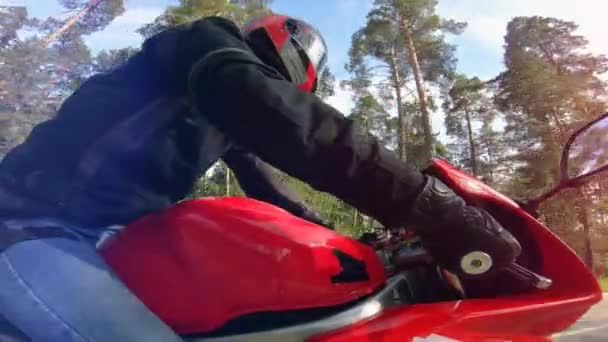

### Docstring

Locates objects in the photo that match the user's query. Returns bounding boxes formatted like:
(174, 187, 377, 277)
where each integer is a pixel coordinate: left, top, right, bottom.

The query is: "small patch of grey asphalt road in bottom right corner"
(554, 293, 608, 342)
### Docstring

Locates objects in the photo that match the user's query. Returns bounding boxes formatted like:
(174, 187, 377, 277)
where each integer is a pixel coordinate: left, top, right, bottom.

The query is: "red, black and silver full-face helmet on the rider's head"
(242, 14, 327, 92)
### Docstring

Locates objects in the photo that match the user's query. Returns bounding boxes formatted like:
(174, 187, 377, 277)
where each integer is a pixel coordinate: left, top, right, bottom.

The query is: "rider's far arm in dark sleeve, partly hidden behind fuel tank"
(222, 147, 327, 226)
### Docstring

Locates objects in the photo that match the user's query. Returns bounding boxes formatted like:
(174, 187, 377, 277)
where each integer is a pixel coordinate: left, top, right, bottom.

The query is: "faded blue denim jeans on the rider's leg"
(0, 219, 182, 342)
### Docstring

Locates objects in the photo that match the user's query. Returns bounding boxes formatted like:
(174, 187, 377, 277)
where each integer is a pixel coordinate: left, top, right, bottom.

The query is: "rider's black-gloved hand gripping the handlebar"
(408, 176, 521, 277)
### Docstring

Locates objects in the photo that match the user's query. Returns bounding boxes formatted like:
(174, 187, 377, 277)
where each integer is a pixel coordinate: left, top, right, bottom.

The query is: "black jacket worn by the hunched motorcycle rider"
(0, 18, 424, 230)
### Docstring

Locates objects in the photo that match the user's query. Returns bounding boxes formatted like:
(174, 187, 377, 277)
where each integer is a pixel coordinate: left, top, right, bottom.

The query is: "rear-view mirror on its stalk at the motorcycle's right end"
(523, 112, 608, 213)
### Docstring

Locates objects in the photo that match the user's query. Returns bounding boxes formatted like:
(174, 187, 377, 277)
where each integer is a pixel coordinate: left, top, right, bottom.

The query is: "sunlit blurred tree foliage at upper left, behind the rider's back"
(0, 0, 124, 158)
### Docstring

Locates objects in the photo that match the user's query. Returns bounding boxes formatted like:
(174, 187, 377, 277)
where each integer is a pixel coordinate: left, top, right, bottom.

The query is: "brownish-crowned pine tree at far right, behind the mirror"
(497, 16, 608, 267)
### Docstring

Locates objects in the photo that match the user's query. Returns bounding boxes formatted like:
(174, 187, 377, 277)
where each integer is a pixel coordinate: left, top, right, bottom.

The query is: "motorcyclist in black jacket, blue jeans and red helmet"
(0, 15, 519, 341)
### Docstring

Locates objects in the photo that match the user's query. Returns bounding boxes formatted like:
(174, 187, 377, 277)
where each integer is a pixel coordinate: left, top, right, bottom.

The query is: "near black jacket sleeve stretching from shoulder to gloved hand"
(143, 18, 425, 226)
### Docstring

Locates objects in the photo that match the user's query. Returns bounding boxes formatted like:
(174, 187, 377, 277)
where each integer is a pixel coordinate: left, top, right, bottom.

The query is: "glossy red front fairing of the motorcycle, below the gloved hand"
(307, 159, 602, 342)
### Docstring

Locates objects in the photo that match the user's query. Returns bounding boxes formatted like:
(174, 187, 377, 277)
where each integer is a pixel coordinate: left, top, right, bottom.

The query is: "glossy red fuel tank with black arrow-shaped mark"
(101, 197, 386, 334)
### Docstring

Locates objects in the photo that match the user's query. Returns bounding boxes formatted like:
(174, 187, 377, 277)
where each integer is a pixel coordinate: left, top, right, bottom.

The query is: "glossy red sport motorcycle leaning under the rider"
(102, 114, 608, 342)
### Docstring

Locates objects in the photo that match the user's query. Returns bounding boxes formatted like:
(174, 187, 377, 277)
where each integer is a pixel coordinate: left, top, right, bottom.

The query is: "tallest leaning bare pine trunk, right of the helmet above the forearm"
(400, 16, 435, 162)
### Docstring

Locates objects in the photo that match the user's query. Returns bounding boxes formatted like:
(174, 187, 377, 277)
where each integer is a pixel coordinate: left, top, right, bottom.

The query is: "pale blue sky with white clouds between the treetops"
(8, 0, 608, 121)
